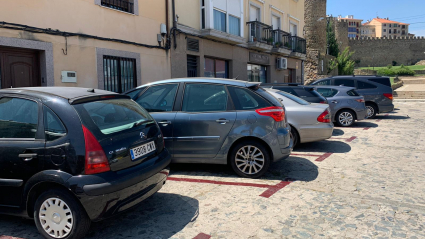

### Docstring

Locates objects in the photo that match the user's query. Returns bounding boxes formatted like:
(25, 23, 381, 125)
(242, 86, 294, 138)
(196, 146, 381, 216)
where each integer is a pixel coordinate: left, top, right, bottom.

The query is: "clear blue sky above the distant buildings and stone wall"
(327, 0, 425, 36)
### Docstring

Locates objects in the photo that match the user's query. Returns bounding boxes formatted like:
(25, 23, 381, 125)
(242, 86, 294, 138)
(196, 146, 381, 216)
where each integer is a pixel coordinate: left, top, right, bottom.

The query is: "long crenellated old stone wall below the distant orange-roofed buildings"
(348, 37, 425, 67)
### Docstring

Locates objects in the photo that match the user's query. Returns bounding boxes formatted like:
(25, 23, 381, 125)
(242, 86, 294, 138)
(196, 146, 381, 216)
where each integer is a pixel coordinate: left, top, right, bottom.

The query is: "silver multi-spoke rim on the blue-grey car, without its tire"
(235, 145, 265, 175)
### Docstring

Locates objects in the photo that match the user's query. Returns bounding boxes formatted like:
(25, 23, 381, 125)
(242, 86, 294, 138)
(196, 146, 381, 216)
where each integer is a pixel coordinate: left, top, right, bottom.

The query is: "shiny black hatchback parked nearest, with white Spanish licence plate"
(0, 87, 171, 238)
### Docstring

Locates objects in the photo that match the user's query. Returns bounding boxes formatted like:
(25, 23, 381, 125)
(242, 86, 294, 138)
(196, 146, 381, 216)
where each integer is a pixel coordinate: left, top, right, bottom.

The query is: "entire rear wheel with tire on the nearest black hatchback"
(34, 189, 91, 239)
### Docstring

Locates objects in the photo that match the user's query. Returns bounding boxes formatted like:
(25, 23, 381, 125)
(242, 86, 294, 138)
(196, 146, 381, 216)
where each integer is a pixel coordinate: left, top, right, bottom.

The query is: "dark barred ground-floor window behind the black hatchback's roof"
(103, 56, 137, 93)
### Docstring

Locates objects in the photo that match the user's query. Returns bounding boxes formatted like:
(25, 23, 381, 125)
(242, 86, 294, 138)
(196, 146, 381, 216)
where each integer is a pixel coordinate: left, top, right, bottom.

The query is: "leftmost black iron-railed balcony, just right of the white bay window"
(246, 21, 274, 51)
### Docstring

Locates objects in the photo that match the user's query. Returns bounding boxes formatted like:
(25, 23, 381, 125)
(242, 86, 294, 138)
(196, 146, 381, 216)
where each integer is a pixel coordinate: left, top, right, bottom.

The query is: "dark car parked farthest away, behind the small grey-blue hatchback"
(311, 76, 394, 119)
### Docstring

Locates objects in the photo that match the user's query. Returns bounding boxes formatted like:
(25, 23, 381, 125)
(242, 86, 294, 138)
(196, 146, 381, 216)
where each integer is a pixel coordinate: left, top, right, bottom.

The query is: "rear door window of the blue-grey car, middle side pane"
(182, 84, 228, 112)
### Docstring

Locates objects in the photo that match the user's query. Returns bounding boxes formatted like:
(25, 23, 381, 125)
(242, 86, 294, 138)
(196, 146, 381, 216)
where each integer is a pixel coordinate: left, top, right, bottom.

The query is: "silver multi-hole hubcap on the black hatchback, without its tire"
(38, 198, 74, 238)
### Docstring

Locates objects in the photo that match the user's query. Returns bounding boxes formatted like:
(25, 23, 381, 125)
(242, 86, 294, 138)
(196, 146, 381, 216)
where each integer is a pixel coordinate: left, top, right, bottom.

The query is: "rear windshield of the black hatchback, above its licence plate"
(75, 99, 153, 135)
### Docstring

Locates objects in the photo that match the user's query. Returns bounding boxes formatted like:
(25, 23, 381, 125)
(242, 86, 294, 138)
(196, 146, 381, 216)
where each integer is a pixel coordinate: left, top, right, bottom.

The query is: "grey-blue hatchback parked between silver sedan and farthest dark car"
(316, 86, 367, 127)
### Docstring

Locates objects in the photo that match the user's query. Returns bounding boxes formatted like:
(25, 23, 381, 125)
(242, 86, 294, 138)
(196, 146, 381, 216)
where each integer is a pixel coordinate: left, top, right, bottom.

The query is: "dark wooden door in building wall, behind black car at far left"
(0, 48, 41, 88)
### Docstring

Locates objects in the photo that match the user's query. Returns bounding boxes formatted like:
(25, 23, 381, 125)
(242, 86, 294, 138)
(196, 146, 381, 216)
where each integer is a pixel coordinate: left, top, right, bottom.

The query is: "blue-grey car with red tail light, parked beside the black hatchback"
(127, 78, 293, 178)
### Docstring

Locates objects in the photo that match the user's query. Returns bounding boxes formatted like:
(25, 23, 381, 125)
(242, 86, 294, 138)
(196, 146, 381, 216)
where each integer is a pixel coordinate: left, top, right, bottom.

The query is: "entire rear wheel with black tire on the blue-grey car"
(230, 140, 272, 178)
